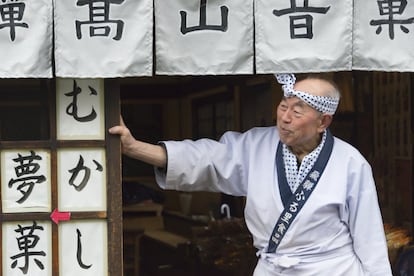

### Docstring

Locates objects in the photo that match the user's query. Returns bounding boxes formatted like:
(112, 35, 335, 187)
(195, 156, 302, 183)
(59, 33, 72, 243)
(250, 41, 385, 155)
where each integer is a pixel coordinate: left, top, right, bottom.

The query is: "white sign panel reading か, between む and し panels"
(58, 148, 106, 211)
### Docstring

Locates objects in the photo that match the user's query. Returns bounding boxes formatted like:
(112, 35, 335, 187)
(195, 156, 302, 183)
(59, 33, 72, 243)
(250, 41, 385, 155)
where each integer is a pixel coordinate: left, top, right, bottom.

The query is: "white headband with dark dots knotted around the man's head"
(276, 74, 339, 115)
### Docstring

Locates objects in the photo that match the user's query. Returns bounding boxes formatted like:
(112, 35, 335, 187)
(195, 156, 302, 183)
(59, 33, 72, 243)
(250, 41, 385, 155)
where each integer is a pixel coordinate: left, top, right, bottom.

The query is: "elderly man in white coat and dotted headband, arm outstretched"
(109, 74, 392, 276)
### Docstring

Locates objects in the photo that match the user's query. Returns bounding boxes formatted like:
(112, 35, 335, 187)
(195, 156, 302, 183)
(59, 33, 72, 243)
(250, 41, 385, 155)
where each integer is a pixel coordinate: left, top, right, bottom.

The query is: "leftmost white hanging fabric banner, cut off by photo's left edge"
(0, 0, 53, 78)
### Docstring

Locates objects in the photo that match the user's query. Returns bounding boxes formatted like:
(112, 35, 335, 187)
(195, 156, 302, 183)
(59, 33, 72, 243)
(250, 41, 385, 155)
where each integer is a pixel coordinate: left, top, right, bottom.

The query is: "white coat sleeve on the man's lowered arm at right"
(347, 162, 392, 276)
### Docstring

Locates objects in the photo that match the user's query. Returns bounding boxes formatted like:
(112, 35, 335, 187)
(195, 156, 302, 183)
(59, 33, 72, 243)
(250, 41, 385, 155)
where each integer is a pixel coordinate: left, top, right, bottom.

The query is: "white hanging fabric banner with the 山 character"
(155, 0, 253, 75)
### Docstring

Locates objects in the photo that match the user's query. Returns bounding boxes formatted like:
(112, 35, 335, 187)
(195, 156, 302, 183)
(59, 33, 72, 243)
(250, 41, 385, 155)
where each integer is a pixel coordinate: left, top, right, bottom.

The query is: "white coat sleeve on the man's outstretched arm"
(155, 132, 247, 196)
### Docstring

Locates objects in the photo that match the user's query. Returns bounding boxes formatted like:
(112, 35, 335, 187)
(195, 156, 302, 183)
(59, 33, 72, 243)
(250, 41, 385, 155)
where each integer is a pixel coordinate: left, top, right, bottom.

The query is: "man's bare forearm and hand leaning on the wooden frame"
(108, 118, 167, 168)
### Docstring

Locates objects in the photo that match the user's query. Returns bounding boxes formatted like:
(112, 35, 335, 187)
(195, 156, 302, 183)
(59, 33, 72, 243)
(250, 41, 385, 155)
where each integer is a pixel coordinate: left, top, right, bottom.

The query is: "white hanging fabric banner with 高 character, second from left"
(54, 0, 153, 78)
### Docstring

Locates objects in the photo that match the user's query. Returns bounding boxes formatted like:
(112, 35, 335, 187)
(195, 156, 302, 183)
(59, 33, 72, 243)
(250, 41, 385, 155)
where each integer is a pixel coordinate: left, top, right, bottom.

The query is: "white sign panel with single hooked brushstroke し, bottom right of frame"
(59, 220, 108, 276)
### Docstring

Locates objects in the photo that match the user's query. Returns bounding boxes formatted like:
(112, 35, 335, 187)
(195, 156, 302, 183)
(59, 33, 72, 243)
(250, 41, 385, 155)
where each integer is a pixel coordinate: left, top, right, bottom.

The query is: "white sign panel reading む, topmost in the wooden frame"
(56, 78, 105, 140)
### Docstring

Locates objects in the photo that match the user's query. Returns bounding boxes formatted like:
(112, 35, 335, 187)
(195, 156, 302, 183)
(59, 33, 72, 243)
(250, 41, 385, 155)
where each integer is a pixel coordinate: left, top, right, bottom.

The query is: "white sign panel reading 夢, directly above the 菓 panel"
(1, 149, 51, 213)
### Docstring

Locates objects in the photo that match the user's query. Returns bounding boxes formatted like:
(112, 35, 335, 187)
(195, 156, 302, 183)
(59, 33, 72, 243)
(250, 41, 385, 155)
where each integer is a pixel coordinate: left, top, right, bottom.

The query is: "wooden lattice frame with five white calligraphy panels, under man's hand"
(0, 79, 123, 276)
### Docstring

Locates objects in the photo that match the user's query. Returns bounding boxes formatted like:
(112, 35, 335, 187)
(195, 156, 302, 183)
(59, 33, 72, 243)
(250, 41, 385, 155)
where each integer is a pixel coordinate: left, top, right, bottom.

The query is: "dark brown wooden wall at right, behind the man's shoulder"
(354, 72, 414, 231)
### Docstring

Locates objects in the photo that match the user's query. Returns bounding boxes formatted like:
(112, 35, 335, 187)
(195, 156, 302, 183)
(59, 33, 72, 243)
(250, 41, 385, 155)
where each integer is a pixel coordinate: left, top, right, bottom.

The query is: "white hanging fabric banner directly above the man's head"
(255, 0, 352, 73)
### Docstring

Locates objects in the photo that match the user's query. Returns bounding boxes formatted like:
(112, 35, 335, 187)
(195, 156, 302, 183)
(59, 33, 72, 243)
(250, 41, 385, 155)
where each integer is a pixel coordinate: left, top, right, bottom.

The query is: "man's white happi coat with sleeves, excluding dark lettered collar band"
(156, 127, 392, 276)
